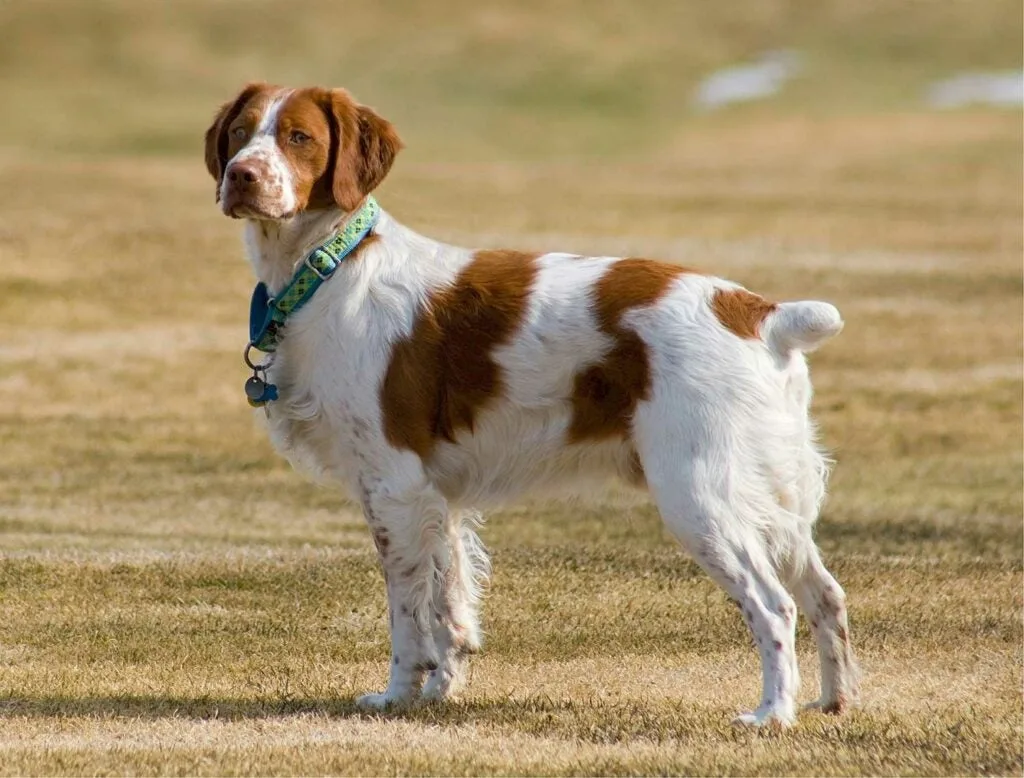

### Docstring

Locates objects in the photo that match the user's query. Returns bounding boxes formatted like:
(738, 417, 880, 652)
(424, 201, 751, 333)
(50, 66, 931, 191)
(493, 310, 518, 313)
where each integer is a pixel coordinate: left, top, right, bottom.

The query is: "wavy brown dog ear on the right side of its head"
(325, 89, 402, 211)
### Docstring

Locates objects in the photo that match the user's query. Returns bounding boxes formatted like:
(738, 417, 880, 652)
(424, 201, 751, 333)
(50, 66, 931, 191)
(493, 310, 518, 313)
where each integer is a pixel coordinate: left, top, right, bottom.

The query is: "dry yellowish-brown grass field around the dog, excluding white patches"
(0, 0, 1024, 775)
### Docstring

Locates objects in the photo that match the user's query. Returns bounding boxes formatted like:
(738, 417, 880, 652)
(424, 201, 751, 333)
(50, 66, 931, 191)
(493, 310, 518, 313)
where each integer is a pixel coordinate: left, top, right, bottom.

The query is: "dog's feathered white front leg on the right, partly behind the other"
(423, 511, 490, 699)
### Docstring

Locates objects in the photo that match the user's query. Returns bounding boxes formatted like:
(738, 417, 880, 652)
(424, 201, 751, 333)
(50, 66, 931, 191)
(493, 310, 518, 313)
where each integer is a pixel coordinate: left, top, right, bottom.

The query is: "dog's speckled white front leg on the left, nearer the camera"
(356, 470, 447, 708)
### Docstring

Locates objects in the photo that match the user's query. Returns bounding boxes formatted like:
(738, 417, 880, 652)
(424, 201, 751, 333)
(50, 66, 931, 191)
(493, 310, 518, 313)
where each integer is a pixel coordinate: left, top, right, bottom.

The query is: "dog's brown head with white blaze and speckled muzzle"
(206, 83, 401, 221)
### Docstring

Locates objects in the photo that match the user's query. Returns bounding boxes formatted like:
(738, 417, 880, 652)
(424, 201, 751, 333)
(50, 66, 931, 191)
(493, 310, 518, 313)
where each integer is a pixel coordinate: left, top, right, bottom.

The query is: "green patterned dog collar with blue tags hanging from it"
(244, 197, 381, 407)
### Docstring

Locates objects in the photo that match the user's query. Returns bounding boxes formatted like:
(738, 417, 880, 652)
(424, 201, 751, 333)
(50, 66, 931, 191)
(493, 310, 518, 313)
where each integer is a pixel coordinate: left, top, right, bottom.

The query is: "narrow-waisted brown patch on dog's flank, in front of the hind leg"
(568, 258, 689, 443)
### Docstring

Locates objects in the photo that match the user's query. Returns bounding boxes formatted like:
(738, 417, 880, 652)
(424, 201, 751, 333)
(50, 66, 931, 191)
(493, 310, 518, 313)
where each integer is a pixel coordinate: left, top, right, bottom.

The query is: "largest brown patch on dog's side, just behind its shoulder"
(381, 251, 538, 459)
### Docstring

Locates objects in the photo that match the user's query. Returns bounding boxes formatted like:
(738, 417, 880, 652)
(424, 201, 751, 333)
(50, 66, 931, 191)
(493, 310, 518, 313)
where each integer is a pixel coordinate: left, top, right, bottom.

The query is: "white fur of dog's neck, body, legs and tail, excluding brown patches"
(228, 125, 856, 725)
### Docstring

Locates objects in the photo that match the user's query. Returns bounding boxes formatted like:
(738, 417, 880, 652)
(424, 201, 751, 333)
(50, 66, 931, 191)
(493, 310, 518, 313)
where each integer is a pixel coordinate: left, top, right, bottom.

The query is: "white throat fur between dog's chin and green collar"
(245, 208, 348, 296)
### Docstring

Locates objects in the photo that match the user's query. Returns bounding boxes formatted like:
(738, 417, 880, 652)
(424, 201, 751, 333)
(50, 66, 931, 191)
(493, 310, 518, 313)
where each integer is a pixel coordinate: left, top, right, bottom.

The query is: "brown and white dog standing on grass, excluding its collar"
(206, 84, 857, 725)
